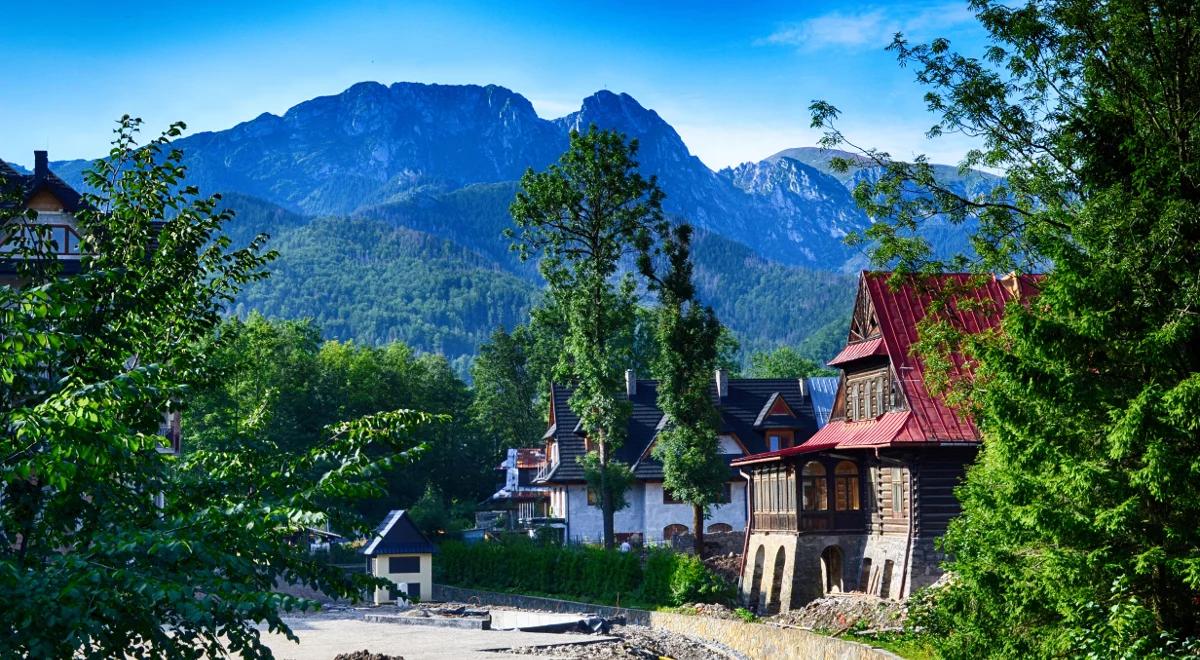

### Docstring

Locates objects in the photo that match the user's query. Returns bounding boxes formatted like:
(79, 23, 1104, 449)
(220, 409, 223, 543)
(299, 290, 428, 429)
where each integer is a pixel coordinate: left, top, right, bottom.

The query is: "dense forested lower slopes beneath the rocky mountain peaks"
(213, 189, 854, 377)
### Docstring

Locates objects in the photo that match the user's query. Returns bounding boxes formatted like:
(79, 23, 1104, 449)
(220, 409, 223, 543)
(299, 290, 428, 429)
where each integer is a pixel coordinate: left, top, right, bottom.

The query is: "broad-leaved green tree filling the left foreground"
(0, 118, 432, 658)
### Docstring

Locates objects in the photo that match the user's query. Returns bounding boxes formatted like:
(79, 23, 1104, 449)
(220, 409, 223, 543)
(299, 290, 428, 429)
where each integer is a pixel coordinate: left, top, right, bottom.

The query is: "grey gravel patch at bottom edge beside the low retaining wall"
(505, 625, 733, 660)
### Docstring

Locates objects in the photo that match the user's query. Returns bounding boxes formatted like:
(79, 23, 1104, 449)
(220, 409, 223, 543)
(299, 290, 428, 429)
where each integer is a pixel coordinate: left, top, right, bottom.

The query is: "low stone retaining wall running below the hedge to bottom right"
(433, 584, 900, 660)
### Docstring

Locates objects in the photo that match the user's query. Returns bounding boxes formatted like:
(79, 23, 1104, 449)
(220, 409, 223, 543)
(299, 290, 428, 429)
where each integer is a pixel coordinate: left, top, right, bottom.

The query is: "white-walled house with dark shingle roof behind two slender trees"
(534, 371, 835, 544)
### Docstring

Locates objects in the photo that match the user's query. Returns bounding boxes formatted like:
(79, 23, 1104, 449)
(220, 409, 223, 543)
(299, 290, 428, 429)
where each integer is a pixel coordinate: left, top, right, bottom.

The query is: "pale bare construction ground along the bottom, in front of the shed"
(263, 607, 732, 660)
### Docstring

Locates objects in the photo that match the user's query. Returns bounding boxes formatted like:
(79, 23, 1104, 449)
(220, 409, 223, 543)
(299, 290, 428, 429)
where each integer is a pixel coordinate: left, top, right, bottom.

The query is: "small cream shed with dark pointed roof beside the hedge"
(362, 509, 438, 605)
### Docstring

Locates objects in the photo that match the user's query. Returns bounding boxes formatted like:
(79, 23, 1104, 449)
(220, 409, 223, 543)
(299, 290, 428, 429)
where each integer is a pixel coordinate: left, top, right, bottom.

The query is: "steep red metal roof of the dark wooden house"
(740, 271, 1042, 463)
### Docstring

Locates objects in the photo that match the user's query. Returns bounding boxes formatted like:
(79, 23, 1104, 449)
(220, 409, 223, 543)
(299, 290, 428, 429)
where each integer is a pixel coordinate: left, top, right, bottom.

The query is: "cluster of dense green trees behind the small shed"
(184, 313, 499, 528)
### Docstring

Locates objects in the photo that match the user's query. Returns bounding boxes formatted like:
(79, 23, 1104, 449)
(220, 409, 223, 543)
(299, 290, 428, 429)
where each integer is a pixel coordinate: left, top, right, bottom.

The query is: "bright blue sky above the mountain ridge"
(0, 0, 983, 168)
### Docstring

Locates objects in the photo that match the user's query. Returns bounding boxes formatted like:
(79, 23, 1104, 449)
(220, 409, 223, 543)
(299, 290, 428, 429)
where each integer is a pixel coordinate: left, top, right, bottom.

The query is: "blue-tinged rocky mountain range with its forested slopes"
(39, 83, 996, 369)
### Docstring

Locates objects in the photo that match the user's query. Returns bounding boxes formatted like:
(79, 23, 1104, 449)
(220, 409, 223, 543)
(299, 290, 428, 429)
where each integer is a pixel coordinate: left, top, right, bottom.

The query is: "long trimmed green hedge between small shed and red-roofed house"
(433, 538, 736, 606)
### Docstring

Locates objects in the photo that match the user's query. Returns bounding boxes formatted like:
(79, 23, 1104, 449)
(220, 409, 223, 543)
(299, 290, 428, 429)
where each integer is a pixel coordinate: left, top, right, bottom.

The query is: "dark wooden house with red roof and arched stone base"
(733, 272, 1037, 612)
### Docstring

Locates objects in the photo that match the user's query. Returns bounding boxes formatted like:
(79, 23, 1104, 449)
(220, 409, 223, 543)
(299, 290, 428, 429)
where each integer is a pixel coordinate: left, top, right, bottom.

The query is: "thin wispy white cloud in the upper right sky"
(757, 2, 974, 50)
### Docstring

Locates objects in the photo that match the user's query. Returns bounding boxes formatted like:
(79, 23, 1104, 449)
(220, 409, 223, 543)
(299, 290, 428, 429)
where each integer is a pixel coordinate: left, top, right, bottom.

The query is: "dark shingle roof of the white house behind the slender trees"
(546, 378, 817, 482)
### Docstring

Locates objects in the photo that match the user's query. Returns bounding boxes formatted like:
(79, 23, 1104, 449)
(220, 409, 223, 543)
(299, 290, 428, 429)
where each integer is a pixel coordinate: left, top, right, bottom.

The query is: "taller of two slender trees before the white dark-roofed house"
(508, 126, 666, 547)
